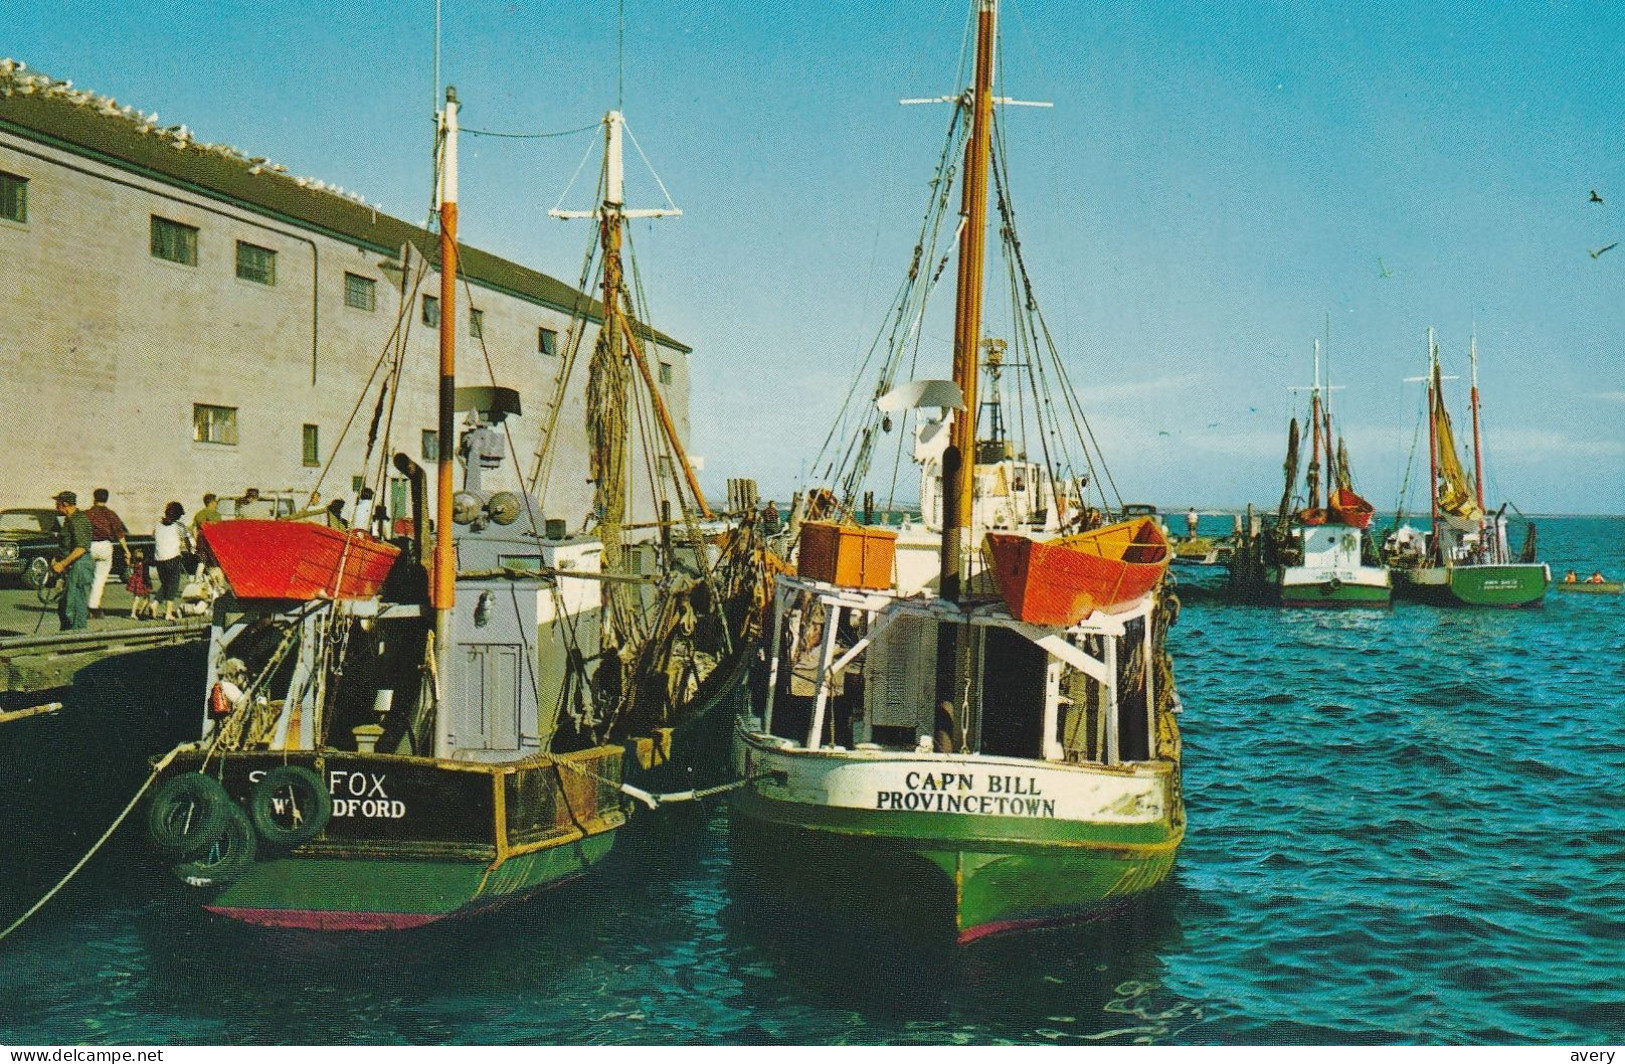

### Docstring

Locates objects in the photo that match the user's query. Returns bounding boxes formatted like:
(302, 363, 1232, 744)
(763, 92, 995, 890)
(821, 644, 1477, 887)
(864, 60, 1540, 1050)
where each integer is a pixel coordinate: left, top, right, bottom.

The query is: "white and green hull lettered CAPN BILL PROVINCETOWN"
(733, 733, 1185, 942)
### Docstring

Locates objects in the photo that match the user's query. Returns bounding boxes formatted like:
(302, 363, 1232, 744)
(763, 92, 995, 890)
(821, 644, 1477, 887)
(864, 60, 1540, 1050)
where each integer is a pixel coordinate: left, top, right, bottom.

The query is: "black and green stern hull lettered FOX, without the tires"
(160, 747, 626, 931)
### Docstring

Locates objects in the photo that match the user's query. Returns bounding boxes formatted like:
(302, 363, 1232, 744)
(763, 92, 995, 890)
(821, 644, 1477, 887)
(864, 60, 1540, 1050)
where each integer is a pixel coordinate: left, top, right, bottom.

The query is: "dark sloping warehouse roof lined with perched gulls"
(0, 58, 692, 353)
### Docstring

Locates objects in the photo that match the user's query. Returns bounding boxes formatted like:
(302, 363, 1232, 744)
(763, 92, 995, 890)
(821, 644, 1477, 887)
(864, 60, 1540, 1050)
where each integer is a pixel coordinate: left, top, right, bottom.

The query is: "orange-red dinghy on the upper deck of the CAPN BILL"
(986, 518, 1170, 627)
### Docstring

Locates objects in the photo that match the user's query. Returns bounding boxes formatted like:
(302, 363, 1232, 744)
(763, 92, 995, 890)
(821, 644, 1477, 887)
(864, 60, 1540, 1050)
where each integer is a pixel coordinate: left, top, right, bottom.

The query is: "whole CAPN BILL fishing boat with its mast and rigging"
(731, 0, 1185, 942)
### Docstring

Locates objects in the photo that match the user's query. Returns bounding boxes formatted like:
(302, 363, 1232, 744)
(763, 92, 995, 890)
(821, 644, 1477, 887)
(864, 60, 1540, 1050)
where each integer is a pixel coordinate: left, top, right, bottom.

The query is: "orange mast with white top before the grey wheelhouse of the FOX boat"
(429, 86, 458, 757)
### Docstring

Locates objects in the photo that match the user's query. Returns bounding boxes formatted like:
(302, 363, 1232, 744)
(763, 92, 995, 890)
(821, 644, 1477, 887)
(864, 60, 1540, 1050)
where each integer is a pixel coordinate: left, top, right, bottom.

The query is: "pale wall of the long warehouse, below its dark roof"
(0, 132, 689, 528)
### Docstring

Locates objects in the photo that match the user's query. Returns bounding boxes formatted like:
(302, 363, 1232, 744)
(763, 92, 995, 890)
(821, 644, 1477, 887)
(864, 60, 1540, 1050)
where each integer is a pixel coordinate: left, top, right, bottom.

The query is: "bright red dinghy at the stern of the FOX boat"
(200, 520, 400, 601)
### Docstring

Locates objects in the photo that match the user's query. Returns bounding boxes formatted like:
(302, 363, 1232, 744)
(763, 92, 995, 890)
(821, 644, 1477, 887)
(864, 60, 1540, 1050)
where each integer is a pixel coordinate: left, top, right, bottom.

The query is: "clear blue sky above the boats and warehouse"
(12, 0, 1625, 513)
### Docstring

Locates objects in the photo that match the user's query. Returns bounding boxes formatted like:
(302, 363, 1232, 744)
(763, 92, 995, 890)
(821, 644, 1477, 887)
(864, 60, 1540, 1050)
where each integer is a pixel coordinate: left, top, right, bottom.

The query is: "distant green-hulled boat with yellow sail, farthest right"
(1385, 330, 1552, 608)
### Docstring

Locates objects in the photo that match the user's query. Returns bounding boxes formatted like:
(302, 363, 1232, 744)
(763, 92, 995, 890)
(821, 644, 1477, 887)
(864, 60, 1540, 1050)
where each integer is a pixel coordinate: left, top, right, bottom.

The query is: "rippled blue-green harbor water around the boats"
(0, 518, 1625, 1045)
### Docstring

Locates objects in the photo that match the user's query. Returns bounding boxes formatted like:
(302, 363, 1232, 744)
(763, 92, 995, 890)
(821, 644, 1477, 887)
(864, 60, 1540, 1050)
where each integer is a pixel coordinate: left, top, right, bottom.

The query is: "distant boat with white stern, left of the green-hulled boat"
(1229, 341, 1393, 608)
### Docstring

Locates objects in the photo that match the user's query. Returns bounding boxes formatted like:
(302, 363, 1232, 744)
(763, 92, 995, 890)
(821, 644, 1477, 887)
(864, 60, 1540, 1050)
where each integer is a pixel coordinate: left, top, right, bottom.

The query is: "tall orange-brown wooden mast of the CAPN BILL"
(941, 0, 998, 601)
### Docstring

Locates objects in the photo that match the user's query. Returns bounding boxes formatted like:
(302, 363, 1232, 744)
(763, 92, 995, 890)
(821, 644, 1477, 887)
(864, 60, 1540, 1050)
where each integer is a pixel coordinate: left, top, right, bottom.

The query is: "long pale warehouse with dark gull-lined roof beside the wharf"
(0, 60, 691, 528)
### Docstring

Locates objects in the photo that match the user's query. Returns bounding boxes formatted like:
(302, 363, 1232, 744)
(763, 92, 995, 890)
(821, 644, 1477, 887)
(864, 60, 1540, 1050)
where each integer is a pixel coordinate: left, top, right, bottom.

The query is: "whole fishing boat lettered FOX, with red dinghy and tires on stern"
(146, 91, 754, 931)
